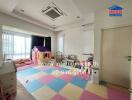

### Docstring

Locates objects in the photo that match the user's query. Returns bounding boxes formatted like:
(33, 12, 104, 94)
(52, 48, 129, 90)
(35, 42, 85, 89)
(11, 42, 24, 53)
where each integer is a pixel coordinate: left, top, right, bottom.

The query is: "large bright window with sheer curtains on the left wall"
(2, 31, 31, 59)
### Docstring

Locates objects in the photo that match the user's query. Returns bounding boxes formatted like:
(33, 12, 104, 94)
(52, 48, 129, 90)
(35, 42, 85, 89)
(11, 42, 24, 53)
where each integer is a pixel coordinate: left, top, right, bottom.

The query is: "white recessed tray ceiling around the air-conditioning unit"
(0, 0, 127, 31)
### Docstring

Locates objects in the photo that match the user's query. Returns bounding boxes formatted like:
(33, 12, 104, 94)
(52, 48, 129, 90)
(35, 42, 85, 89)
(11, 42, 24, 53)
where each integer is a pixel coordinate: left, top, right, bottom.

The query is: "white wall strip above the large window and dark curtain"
(0, 13, 56, 52)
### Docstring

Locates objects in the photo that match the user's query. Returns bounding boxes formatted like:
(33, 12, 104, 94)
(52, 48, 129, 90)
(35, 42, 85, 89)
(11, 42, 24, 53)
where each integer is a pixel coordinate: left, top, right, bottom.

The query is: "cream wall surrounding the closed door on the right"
(94, 0, 132, 80)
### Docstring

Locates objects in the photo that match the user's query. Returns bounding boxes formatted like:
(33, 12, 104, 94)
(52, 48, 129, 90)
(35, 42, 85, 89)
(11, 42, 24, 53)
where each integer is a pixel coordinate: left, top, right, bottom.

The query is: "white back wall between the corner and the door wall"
(57, 24, 94, 60)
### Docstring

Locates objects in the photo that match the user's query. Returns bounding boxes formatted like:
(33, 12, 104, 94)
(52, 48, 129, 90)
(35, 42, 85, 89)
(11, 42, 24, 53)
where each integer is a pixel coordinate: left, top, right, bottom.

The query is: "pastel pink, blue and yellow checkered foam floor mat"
(17, 66, 130, 100)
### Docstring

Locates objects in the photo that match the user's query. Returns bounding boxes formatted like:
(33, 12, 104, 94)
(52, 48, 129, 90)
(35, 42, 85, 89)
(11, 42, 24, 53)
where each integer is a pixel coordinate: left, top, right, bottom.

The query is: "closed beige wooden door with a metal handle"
(102, 26, 132, 88)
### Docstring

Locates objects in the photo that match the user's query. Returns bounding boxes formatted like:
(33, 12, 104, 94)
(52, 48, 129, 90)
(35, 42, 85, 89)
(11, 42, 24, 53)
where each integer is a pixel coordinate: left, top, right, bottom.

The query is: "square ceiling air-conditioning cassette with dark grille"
(41, 2, 65, 20)
